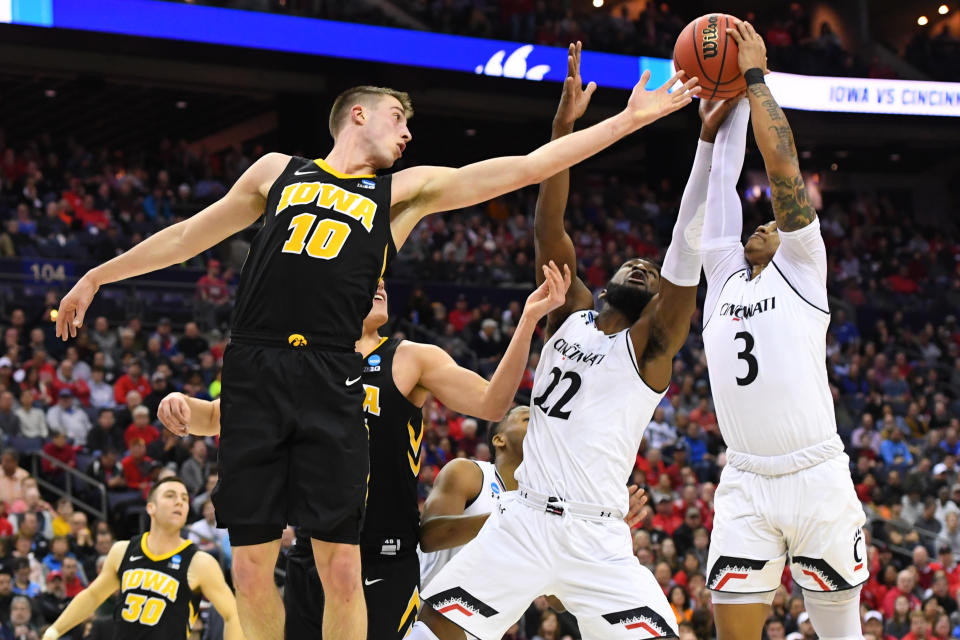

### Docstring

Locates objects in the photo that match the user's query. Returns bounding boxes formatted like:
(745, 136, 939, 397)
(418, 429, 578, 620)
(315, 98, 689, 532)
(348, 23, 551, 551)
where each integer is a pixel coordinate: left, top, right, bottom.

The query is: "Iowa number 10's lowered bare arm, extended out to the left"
(57, 153, 290, 340)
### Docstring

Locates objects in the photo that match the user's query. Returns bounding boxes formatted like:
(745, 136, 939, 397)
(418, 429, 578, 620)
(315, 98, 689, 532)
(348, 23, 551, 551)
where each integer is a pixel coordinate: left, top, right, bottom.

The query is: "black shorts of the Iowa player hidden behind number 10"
(283, 544, 420, 640)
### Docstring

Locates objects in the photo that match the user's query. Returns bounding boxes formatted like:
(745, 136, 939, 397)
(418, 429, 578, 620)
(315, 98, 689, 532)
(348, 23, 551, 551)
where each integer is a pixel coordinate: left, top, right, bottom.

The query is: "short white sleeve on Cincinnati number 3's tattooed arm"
(773, 217, 828, 313)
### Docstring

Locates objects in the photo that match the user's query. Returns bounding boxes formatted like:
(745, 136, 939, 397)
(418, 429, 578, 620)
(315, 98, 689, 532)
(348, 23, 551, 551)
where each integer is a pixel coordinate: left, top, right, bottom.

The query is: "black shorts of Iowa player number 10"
(213, 341, 370, 545)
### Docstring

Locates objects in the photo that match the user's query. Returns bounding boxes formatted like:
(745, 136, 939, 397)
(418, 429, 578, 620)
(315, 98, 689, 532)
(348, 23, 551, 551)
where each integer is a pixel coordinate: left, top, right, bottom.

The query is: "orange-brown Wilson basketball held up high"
(673, 13, 747, 100)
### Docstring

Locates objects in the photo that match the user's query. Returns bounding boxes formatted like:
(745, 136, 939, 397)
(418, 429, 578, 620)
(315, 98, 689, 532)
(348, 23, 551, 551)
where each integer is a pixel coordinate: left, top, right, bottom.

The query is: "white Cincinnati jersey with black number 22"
(515, 311, 663, 513)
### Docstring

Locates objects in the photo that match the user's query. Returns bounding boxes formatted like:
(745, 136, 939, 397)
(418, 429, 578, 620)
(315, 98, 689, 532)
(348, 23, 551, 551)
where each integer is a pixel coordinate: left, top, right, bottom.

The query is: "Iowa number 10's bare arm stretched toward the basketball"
(391, 71, 699, 246)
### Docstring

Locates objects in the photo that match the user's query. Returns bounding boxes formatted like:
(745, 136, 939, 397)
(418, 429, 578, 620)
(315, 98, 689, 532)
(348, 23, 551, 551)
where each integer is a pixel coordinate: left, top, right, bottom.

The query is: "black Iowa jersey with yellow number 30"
(113, 533, 201, 640)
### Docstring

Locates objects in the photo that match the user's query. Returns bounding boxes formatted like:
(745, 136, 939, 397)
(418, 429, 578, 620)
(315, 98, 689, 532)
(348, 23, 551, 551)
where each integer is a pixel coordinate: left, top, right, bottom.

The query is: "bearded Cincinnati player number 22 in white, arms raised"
(410, 47, 706, 640)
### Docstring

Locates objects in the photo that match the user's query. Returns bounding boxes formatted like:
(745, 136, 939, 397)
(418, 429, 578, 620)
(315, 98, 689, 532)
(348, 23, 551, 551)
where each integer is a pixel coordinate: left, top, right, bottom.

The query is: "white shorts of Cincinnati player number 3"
(707, 455, 869, 602)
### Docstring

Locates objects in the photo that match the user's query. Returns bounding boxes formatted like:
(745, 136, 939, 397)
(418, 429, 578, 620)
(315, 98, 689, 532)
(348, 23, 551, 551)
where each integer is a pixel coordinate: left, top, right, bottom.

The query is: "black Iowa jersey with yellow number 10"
(233, 157, 396, 351)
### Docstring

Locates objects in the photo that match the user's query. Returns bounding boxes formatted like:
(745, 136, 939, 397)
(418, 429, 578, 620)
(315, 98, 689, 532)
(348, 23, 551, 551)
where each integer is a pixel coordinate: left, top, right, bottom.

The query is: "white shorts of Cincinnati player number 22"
(422, 492, 677, 640)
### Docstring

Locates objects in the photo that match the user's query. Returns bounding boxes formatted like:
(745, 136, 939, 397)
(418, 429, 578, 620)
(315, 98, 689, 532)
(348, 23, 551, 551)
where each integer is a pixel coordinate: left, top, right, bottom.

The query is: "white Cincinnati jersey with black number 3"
(703, 219, 837, 456)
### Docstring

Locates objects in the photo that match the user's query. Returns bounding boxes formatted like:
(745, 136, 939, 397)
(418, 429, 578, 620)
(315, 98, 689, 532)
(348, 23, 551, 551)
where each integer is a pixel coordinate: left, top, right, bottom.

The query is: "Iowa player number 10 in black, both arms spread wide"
(57, 66, 699, 640)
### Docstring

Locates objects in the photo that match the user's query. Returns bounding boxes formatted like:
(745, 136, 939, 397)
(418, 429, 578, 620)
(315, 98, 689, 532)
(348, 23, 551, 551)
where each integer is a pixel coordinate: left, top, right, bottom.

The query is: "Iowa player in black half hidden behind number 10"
(157, 265, 570, 640)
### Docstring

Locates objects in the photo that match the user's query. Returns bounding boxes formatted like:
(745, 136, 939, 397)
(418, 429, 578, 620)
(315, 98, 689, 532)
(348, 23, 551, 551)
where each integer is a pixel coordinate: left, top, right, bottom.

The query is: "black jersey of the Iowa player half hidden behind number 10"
(360, 338, 423, 555)
